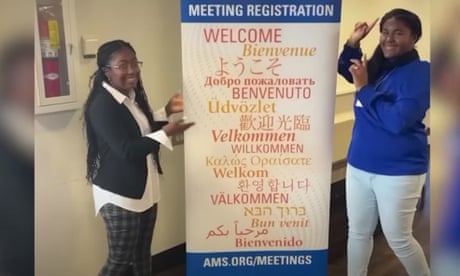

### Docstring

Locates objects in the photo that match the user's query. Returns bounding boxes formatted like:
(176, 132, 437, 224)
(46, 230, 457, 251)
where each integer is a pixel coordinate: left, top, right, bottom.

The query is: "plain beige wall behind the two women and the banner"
(35, 0, 429, 276)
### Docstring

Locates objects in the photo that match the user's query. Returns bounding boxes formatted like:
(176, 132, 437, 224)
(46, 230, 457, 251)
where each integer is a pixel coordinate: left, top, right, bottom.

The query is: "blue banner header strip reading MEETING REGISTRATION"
(181, 0, 341, 23)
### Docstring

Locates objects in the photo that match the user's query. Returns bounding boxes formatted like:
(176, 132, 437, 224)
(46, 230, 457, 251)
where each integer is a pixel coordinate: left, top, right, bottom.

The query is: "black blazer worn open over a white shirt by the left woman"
(86, 86, 167, 199)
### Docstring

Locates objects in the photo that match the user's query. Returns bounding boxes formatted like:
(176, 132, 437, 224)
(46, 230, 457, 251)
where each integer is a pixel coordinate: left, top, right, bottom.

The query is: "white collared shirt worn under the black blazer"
(93, 82, 173, 215)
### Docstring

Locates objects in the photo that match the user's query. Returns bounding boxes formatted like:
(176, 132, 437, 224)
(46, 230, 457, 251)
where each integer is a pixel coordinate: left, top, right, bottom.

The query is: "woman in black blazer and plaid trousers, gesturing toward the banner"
(84, 40, 193, 276)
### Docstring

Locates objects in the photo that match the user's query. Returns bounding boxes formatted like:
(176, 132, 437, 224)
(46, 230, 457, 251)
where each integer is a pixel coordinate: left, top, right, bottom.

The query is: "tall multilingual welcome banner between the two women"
(181, 0, 341, 276)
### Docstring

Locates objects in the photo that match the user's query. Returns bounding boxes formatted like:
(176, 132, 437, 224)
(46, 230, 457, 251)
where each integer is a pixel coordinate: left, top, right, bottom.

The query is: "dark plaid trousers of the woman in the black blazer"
(99, 203, 157, 276)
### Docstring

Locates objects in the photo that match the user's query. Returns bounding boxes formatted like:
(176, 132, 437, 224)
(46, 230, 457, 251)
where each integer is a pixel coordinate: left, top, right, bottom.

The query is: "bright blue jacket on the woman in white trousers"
(338, 45, 430, 175)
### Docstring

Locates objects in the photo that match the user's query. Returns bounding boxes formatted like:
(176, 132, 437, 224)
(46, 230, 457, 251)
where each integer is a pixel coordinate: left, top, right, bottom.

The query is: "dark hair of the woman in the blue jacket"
(367, 8, 422, 83)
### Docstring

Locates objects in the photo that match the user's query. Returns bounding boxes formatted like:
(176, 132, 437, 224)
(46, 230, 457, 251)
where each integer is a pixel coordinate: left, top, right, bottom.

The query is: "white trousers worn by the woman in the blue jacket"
(346, 164, 430, 276)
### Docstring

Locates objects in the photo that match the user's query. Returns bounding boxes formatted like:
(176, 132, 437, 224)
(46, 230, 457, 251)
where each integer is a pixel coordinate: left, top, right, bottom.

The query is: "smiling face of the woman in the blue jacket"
(380, 17, 417, 58)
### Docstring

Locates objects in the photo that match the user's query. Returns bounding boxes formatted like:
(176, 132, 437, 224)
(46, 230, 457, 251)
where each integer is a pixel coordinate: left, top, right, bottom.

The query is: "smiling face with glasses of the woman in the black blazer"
(105, 47, 140, 93)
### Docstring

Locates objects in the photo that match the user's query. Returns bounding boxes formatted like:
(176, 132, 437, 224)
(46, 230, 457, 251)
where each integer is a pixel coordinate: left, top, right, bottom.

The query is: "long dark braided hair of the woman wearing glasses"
(83, 40, 154, 182)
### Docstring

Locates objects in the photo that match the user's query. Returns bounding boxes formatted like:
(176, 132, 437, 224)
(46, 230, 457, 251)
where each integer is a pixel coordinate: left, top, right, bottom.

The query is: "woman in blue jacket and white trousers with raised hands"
(338, 9, 430, 276)
